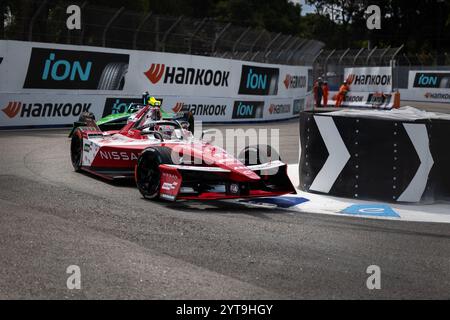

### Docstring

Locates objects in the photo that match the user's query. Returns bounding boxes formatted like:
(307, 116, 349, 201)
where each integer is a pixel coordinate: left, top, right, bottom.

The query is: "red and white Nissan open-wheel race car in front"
(71, 106, 295, 201)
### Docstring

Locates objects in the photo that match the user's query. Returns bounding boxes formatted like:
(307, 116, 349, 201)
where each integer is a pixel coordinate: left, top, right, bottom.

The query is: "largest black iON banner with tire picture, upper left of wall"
(23, 48, 129, 90)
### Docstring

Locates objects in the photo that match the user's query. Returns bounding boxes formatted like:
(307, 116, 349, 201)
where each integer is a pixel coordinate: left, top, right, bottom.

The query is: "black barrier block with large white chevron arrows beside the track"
(299, 107, 450, 202)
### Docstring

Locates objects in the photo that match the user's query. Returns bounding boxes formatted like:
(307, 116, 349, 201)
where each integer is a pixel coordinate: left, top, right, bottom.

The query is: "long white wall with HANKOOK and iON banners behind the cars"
(0, 40, 312, 128)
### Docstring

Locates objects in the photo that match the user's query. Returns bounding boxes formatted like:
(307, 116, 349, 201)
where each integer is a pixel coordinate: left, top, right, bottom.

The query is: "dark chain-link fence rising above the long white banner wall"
(0, 0, 324, 65)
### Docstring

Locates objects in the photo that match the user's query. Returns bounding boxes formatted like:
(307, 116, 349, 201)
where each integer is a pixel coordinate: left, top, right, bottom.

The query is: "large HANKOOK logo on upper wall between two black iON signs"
(144, 63, 230, 87)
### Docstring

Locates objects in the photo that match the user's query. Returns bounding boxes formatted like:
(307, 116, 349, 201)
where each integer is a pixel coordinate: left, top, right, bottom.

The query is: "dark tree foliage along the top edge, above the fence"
(0, 0, 450, 53)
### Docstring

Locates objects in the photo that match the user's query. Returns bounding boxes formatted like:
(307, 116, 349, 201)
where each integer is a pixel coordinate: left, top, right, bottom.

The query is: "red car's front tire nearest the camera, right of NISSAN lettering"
(135, 147, 173, 200)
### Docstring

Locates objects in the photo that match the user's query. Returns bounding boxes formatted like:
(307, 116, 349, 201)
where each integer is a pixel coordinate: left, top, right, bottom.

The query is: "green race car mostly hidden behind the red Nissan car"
(69, 103, 194, 138)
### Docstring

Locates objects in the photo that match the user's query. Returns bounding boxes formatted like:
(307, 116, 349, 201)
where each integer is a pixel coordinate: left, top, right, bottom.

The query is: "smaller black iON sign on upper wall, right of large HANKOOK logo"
(239, 65, 279, 95)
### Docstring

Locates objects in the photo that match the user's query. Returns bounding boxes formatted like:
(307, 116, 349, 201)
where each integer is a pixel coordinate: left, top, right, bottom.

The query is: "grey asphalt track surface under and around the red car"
(0, 121, 450, 299)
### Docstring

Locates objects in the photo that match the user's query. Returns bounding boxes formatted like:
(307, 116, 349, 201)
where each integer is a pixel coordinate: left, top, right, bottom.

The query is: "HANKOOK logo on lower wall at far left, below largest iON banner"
(2, 101, 92, 118)
